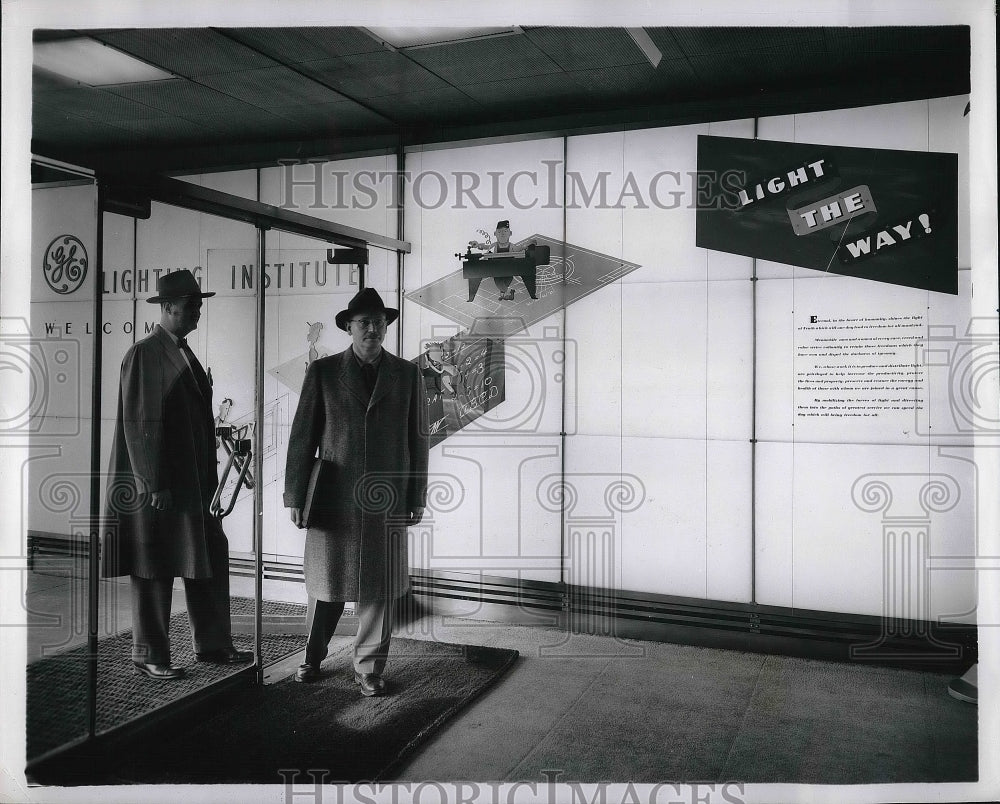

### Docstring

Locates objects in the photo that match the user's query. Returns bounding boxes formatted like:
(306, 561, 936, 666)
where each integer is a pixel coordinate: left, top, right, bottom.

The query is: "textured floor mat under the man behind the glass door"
(25, 598, 305, 760)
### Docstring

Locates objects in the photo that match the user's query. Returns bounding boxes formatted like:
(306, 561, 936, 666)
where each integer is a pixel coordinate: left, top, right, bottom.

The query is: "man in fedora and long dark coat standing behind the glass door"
(102, 270, 253, 680)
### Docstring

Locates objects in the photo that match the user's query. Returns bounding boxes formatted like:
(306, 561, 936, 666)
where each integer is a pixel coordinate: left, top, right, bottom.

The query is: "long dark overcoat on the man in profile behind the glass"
(102, 324, 218, 578)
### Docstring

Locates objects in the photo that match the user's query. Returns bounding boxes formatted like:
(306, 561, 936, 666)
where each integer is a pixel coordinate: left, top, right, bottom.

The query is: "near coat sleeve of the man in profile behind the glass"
(121, 348, 166, 492)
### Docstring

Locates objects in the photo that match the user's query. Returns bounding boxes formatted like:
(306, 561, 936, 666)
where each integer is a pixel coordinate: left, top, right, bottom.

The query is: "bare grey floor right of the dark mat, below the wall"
(388, 618, 978, 784)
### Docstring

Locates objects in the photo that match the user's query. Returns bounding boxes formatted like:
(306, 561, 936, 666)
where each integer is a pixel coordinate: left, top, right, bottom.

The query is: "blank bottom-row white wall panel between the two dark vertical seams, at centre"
(564, 435, 751, 601)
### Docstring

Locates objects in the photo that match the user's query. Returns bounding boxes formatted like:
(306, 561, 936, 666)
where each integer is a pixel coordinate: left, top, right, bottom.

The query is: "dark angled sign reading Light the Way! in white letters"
(696, 136, 958, 294)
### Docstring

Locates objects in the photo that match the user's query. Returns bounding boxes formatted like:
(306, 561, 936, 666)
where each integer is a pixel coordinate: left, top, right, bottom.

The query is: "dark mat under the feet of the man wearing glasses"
(98, 639, 518, 784)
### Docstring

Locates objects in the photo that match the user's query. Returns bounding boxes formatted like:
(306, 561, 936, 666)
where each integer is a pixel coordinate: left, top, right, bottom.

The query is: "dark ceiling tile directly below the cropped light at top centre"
(406, 34, 560, 86)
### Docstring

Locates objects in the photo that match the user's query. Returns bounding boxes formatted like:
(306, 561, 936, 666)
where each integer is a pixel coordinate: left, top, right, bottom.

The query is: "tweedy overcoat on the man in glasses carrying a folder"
(284, 347, 428, 602)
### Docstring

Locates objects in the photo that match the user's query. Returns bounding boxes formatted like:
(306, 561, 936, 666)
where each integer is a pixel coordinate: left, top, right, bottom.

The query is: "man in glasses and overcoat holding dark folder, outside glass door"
(284, 288, 428, 696)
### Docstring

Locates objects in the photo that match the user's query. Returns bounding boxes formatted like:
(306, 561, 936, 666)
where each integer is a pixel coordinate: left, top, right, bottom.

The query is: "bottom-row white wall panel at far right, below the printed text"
(757, 444, 980, 620)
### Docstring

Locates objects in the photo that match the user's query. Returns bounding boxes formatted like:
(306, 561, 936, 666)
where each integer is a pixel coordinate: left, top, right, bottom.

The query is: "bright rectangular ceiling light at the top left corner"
(33, 37, 175, 87)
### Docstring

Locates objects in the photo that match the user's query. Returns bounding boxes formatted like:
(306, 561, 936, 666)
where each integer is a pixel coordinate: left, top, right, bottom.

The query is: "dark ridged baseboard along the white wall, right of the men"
(410, 571, 978, 674)
